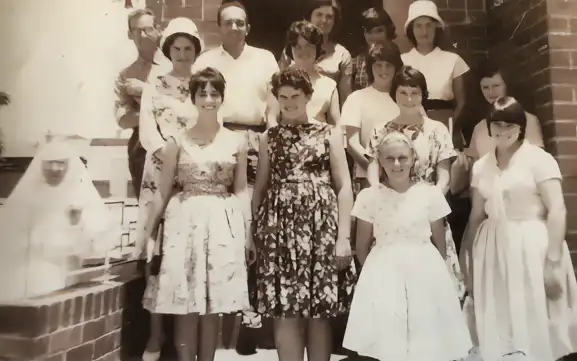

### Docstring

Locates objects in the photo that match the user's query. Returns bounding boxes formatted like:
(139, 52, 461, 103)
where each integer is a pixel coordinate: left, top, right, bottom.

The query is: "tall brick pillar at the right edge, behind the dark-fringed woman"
(488, 0, 577, 264)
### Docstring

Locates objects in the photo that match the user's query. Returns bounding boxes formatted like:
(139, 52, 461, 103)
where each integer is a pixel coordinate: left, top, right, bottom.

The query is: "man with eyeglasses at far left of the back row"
(114, 9, 170, 198)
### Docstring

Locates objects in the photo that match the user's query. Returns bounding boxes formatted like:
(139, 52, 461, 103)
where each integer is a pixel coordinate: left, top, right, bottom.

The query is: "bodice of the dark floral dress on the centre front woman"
(268, 120, 332, 185)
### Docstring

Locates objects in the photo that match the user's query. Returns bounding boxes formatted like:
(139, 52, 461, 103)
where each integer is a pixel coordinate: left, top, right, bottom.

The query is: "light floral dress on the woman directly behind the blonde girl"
(367, 117, 465, 298)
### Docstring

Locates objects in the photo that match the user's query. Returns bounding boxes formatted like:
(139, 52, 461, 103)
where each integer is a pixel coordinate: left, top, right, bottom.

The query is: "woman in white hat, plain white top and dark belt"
(402, 0, 469, 148)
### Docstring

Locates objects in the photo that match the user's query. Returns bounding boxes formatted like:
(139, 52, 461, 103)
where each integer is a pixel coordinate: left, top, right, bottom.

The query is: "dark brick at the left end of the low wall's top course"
(0, 306, 49, 337)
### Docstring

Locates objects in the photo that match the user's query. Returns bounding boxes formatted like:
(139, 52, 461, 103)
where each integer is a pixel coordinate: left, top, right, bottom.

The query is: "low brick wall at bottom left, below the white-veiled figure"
(0, 283, 123, 361)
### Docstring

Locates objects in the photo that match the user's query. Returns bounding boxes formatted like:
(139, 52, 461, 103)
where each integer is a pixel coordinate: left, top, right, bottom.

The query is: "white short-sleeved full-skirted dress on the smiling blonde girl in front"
(343, 183, 472, 361)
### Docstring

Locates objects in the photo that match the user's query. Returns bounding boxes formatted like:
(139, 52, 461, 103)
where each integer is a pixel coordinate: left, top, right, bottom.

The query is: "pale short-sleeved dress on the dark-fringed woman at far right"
(471, 142, 577, 361)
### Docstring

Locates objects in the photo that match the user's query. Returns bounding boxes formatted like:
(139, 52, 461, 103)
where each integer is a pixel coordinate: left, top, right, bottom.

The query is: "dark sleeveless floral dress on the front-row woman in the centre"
(255, 120, 356, 318)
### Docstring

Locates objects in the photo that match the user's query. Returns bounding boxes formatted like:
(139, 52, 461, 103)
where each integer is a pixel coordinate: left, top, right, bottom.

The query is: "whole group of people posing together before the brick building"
(116, 0, 577, 361)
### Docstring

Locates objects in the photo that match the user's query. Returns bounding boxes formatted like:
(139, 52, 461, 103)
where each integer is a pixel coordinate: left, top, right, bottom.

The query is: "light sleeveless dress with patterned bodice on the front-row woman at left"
(144, 129, 249, 315)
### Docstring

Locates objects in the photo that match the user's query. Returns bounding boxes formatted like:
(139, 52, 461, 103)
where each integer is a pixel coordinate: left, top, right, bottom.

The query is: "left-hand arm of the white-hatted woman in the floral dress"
(138, 86, 166, 159)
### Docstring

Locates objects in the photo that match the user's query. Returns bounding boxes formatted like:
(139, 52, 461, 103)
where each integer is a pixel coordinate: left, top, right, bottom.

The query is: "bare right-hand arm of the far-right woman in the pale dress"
(537, 178, 567, 262)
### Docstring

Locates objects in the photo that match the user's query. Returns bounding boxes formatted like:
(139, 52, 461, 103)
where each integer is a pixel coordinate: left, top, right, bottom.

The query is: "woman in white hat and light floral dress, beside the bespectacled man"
(137, 18, 203, 361)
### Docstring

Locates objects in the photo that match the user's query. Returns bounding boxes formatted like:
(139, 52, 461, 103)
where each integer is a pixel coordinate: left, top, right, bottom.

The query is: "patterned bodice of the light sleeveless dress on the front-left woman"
(176, 130, 241, 196)
